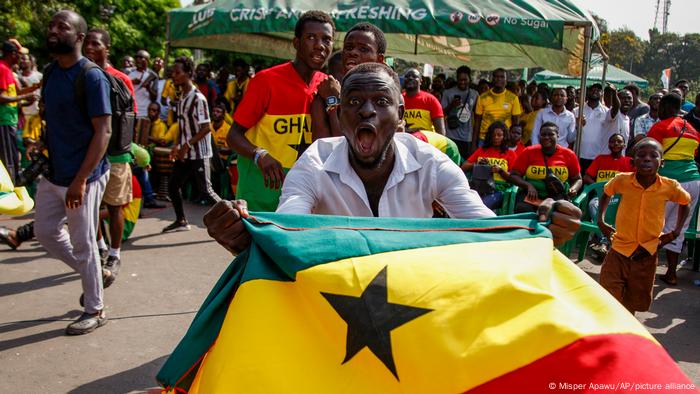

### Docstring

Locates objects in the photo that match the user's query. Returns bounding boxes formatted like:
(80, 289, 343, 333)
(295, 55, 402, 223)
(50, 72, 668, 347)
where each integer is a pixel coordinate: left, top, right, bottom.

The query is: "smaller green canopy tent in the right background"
(532, 56, 649, 89)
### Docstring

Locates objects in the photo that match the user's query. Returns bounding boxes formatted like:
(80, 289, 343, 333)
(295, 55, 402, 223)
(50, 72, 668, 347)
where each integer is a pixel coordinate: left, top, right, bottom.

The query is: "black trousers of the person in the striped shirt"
(168, 159, 221, 221)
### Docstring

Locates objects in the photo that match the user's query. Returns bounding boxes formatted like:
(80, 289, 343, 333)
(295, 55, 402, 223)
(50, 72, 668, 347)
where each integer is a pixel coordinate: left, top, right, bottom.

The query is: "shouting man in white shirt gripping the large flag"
(204, 63, 581, 253)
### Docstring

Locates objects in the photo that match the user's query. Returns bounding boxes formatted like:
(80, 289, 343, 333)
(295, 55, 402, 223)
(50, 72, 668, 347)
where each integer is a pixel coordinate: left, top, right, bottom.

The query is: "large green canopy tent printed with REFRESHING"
(168, 0, 598, 75)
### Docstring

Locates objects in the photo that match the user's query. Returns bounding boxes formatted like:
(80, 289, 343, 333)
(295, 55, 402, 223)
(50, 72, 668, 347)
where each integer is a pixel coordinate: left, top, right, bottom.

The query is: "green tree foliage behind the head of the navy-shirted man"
(0, 0, 180, 67)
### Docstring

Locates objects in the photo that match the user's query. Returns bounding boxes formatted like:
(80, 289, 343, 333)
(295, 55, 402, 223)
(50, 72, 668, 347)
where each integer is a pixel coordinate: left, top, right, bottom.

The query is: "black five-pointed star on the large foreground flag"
(321, 267, 432, 380)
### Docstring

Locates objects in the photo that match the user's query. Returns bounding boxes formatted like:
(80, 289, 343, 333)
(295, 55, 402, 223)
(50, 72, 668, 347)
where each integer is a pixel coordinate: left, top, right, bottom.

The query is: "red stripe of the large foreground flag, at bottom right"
(468, 334, 698, 394)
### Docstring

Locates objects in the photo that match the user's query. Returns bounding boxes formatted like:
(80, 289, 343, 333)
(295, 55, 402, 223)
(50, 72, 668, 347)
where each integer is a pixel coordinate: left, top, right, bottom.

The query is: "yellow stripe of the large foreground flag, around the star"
(190, 238, 653, 393)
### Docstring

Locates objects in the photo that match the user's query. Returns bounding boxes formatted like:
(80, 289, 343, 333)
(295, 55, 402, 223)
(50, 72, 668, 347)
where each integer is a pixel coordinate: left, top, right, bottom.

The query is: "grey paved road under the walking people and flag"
(0, 206, 700, 393)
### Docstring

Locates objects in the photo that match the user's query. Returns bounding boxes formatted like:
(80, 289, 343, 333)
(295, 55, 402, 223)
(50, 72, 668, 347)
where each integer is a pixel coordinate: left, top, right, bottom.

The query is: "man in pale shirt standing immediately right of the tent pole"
(573, 83, 609, 174)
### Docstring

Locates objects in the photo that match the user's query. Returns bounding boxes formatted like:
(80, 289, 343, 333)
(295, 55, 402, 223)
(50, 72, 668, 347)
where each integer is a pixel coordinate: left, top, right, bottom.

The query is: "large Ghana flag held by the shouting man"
(158, 214, 692, 393)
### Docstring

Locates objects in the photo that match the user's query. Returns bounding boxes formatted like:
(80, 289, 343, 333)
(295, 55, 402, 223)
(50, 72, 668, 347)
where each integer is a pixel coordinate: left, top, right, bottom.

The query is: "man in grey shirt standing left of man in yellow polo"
(441, 66, 479, 157)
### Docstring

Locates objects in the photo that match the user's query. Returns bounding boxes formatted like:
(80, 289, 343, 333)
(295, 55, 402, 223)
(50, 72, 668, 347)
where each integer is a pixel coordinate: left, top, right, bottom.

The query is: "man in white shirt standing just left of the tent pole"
(532, 88, 576, 148)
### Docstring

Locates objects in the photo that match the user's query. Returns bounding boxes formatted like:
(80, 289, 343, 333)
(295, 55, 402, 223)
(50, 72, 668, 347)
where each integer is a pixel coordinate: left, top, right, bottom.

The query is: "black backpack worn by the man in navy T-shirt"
(41, 60, 136, 156)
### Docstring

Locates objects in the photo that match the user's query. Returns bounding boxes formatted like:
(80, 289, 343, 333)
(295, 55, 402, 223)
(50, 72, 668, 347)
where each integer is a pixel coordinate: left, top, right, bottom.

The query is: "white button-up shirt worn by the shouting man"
(277, 133, 495, 219)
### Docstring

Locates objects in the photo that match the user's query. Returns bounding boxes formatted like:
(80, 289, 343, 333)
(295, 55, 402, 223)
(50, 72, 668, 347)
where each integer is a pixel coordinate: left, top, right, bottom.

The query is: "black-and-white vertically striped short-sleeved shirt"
(177, 86, 213, 160)
